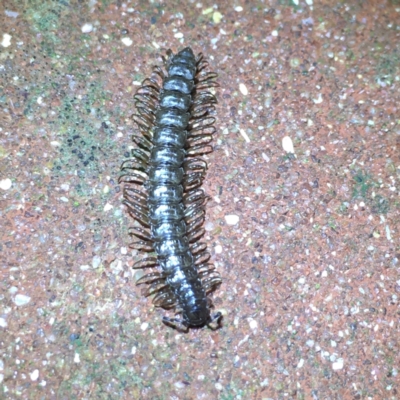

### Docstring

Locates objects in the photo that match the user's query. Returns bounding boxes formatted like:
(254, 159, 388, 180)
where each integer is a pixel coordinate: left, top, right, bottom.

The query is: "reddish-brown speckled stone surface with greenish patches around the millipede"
(0, 0, 400, 400)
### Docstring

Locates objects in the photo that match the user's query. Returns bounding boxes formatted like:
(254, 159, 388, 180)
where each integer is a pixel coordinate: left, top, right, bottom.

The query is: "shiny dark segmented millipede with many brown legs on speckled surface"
(119, 47, 222, 331)
